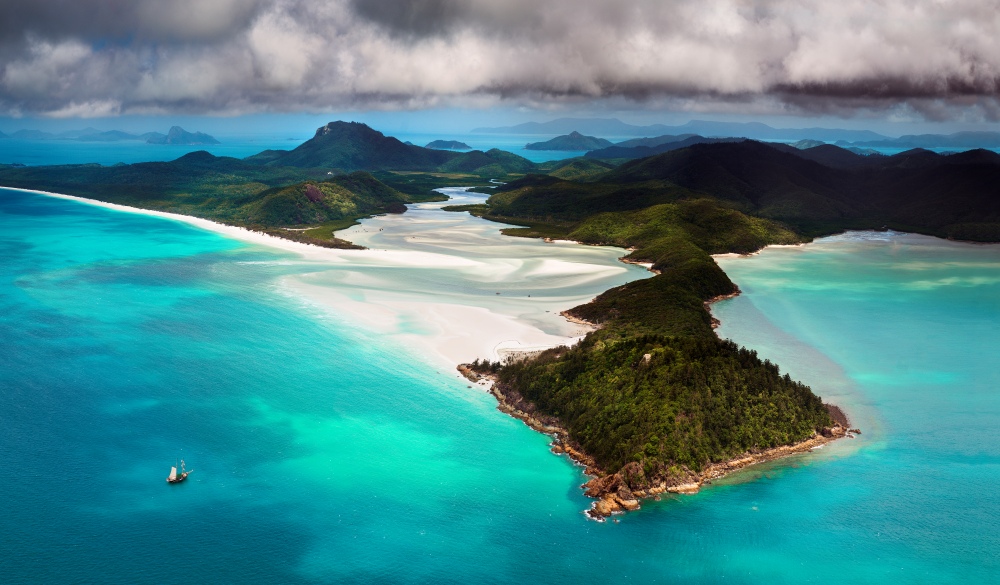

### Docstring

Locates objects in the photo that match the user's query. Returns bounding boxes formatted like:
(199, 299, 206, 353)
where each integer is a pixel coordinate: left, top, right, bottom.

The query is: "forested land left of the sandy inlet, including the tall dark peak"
(0, 122, 535, 247)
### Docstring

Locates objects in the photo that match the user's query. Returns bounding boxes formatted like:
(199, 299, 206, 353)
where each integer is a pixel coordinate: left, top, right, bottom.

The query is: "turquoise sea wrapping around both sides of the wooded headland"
(0, 190, 1000, 583)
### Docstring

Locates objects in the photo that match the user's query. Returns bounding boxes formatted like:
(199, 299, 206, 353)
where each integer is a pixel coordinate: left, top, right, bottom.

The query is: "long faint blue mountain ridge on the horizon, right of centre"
(472, 118, 888, 142)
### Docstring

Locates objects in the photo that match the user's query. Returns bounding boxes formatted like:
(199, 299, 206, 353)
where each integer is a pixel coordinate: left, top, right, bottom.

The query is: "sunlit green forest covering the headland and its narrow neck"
(464, 197, 832, 476)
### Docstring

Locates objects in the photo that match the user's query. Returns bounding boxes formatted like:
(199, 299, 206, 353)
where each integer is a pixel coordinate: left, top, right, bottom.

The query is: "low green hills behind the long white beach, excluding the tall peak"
(0, 152, 426, 247)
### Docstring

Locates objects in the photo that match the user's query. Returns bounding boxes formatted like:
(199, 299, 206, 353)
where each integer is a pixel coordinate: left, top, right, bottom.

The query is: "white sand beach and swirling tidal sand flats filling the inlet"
(15, 189, 650, 368)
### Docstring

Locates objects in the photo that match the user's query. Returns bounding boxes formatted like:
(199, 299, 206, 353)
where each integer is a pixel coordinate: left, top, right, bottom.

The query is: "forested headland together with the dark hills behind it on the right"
(470, 141, 1000, 488)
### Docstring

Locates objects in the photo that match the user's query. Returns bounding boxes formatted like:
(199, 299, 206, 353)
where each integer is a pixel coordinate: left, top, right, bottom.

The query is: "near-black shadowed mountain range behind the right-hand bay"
(603, 141, 1000, 234)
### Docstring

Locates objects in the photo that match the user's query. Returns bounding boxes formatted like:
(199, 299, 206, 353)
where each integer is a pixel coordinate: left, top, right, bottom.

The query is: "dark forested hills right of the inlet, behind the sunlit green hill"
(494, 141, 1000, 241)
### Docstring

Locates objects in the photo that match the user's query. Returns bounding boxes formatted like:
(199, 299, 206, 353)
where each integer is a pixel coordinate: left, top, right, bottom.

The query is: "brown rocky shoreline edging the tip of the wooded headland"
(458, 364, 861, 520)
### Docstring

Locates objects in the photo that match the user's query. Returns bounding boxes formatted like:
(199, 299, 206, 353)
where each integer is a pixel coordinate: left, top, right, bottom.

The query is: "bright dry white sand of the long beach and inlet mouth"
(9, 187, 624, 371)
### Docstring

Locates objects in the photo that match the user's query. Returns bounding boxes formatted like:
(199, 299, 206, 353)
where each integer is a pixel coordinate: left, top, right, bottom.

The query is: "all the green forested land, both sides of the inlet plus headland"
(0, 122, 1000, 515)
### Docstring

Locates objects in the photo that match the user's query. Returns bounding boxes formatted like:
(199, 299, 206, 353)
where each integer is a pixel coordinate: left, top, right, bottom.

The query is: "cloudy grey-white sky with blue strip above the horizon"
(0, 0, 1000, 133)
